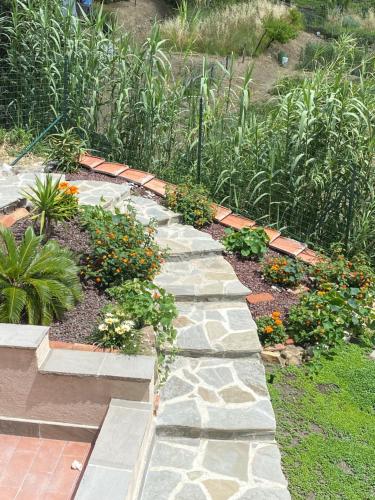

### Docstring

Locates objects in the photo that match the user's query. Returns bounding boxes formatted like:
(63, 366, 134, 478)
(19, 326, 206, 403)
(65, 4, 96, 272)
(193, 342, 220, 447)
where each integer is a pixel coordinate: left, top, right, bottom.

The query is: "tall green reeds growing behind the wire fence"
(2, 0, 375, 261)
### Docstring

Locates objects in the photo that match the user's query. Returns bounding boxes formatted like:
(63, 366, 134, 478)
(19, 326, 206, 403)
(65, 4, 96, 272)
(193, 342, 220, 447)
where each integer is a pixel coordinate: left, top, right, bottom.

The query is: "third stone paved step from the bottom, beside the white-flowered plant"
(164, 301, 262, 358)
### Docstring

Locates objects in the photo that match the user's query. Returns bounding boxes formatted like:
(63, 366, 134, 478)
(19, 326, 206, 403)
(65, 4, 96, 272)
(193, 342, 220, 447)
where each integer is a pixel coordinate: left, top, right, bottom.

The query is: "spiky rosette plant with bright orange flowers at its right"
(23, 174, 78, 237)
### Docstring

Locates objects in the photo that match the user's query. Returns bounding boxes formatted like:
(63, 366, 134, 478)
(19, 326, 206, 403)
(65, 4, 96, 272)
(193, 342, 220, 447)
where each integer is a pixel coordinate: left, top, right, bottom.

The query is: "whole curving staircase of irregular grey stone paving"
(136, 196, 290, 500)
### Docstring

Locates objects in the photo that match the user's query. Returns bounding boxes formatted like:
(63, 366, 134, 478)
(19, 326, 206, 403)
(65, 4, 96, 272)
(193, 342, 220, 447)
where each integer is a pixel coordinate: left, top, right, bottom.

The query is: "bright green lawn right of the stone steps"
(268, 345, 375, 500)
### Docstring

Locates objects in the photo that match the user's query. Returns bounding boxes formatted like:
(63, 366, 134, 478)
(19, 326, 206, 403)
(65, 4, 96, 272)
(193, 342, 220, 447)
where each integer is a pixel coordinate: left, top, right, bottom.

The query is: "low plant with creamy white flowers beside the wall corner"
(94, 305, 142, 354)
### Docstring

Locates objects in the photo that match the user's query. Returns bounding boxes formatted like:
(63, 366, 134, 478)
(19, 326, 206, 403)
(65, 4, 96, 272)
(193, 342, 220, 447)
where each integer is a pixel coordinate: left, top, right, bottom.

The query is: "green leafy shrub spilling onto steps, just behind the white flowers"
(107, 279, 177, 347)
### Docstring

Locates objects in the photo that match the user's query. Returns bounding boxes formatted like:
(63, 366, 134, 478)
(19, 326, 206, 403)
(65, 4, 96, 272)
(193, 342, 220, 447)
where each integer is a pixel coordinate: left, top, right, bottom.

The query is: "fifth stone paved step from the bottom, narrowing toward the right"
(156, 224, 224, 261)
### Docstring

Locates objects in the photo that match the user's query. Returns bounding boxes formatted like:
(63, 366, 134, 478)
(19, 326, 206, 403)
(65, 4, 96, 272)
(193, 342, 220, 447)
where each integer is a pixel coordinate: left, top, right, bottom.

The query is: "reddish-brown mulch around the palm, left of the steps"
(11, 215, 109, 344)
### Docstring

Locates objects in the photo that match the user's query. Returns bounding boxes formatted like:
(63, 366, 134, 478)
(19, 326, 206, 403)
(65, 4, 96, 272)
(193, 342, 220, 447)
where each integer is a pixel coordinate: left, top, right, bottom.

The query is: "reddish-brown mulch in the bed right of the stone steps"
(202, 222, 299, 318)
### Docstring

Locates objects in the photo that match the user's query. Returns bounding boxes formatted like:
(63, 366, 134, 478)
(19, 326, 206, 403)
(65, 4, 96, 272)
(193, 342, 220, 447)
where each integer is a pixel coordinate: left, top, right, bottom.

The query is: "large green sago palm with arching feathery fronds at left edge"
(0, 227, 81, 325)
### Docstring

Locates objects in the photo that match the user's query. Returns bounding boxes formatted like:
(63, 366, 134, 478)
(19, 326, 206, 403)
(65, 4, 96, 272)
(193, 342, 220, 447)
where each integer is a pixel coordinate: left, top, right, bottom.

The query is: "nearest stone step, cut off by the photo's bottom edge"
(141, 437, 291, 500)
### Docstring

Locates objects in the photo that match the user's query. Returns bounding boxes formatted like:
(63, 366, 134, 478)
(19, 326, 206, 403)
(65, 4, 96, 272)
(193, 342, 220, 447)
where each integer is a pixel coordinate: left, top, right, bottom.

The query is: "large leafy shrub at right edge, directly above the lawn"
(287, 289, 375, 348)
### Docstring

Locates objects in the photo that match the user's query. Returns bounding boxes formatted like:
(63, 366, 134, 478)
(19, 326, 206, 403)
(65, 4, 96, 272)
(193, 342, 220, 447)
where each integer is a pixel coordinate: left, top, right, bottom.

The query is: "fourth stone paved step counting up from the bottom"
(154, 255, 250, 301)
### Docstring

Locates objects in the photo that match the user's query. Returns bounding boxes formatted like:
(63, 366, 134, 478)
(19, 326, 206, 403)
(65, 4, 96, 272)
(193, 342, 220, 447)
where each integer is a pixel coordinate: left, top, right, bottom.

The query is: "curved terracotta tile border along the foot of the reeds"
(75, 154, 321, 265)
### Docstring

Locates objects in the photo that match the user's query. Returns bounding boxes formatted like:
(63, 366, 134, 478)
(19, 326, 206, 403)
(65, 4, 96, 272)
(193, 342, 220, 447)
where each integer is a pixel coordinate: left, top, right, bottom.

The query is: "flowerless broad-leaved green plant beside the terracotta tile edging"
(222, 227, 269, 259)
